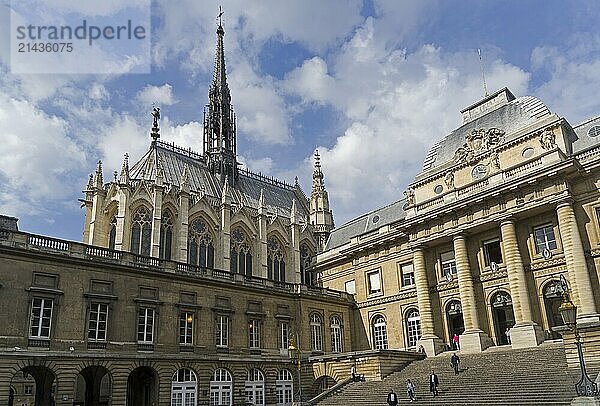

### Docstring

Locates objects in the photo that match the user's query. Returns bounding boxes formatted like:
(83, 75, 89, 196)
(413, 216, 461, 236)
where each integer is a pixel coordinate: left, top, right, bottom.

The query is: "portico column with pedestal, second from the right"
(500, 219, 544, 348)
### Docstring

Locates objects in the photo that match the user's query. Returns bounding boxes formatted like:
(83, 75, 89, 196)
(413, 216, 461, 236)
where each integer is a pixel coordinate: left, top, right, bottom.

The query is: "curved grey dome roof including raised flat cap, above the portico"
(423, 88, 552, 171)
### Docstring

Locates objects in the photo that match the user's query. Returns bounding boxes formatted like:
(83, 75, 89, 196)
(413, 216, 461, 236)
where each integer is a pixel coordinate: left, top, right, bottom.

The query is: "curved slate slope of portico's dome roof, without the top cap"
(423, 96, 552, 171)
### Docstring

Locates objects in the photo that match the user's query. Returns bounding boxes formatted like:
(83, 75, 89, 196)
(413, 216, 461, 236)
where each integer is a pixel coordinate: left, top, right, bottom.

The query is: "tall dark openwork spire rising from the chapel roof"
(204, 9, 238, 185)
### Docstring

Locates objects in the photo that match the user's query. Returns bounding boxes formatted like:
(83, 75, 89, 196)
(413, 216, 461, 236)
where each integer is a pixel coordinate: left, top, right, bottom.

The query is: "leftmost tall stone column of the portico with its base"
(413, 247, 444, 356)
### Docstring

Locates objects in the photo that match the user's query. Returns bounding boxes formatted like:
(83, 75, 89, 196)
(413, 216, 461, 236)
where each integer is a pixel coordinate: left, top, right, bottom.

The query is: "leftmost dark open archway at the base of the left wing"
(9, 365, 56, 406)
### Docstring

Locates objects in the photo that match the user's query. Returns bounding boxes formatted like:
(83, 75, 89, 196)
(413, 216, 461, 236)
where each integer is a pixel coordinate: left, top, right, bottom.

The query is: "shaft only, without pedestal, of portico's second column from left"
(454, 236, 479, 331)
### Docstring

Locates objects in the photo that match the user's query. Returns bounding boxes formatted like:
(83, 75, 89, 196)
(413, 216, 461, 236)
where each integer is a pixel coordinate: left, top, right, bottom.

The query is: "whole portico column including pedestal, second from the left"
(453, 235, 492, 352)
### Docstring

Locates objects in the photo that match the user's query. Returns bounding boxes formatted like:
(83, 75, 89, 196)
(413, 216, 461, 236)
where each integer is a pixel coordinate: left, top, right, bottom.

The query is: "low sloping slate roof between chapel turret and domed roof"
(325, 199, 406, 251)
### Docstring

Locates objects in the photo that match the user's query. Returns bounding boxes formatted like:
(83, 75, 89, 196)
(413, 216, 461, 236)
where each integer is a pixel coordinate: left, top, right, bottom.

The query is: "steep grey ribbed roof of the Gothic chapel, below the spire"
(130, 141, 308, 217)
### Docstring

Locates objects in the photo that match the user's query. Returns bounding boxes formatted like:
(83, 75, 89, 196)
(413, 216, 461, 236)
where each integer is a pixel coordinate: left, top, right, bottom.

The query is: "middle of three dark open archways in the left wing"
(73, 365, 112, 406)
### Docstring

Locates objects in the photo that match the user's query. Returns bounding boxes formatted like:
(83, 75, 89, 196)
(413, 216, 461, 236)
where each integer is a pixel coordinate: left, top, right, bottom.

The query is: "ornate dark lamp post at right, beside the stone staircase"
(558, 275, 598, 396)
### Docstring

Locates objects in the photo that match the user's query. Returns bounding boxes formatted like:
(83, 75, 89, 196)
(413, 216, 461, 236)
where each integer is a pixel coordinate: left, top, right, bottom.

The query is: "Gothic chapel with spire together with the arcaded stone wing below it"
(0, 21, 354, 406)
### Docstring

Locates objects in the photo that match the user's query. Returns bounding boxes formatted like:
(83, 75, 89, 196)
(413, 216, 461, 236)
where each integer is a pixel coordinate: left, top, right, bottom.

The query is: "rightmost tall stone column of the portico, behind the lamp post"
(556, 201, 600, 323)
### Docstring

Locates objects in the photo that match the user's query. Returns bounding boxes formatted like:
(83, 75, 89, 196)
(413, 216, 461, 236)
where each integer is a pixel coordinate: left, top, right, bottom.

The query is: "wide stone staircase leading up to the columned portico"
(318, 342, 576, 406)
